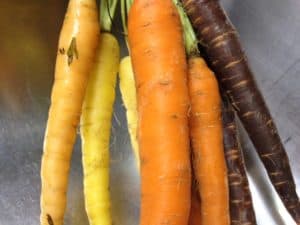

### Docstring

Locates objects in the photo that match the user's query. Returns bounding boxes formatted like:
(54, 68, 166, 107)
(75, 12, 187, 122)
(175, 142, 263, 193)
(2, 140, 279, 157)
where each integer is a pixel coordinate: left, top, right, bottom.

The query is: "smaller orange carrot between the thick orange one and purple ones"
(189, 57, 230, 225)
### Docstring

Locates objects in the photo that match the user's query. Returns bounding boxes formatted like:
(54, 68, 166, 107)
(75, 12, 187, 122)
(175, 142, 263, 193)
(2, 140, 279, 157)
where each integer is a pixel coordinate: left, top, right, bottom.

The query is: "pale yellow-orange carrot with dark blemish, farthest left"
(40, 0, 99, 225)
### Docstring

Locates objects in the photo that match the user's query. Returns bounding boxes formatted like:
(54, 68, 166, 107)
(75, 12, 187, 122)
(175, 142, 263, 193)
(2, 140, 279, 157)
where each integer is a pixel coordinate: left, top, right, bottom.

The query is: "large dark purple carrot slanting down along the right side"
(182, 0, 300, 224)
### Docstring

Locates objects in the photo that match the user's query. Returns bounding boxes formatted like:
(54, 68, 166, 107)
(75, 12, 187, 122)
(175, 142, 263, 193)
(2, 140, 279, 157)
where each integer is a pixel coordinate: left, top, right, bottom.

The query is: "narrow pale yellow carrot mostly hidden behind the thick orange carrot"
(119, 56, 140, 169)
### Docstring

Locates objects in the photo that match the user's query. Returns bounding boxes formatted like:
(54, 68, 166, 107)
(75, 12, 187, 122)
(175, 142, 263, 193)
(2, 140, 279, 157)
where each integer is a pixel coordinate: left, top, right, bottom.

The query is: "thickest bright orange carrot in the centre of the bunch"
(128, 0, 191, 225)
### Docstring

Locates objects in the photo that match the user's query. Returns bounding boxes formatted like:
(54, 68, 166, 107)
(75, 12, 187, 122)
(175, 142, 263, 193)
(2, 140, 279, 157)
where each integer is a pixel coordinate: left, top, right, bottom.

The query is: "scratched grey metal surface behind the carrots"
(0, 0, 300, 225)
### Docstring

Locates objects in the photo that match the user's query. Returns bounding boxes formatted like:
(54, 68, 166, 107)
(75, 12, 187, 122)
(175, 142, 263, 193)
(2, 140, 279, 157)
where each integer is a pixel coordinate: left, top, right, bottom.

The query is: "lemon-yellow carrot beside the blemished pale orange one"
(80, 33, 120, 225)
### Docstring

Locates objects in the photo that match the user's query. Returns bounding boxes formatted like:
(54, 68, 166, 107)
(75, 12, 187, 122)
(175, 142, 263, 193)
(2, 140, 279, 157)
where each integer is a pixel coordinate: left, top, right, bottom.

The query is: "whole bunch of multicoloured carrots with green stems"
(41, 0, 300, 225)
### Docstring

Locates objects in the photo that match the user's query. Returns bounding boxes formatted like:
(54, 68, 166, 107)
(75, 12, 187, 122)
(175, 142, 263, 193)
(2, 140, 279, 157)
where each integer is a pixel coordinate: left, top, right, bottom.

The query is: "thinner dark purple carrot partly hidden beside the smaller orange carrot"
(222, 97, 256, 225)
